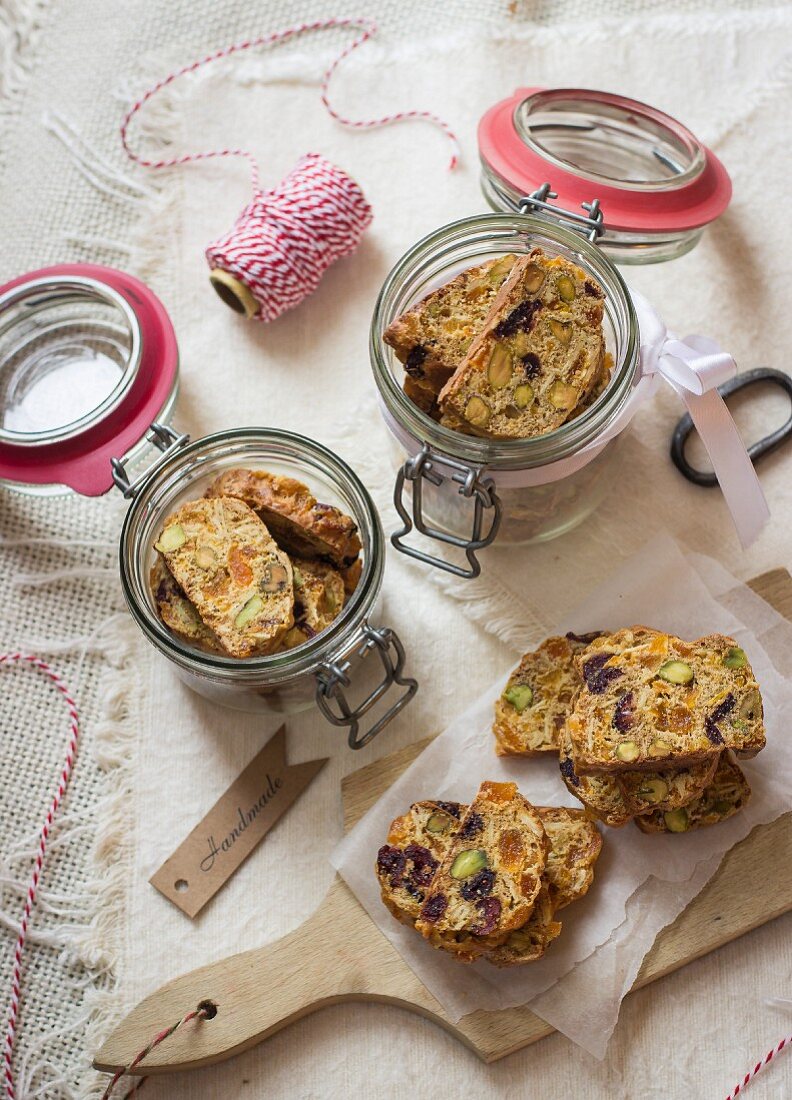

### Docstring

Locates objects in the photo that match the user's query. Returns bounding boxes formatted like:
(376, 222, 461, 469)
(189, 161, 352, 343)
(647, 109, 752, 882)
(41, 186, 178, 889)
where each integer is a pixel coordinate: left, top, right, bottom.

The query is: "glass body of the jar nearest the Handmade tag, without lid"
(120, 428, 415, 739)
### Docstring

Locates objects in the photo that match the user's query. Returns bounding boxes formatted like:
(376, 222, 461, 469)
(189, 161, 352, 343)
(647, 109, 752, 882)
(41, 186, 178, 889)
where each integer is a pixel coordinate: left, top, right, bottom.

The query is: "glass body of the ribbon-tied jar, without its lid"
(371, 215, 640, 563)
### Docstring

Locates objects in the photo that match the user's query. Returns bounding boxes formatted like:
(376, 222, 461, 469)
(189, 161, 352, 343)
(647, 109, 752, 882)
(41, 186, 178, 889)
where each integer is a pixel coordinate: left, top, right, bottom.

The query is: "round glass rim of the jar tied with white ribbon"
(370, 213, 639, 471)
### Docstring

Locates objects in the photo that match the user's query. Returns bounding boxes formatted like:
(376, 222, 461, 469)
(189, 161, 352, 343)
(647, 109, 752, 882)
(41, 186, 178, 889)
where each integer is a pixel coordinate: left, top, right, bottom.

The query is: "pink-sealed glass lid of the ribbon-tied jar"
(479, 88, 732, 236)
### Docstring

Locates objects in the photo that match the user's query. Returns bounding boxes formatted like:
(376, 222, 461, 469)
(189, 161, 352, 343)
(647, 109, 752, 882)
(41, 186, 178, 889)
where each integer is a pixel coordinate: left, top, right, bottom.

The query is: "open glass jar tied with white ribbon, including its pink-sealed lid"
(370, 89, 730, 578)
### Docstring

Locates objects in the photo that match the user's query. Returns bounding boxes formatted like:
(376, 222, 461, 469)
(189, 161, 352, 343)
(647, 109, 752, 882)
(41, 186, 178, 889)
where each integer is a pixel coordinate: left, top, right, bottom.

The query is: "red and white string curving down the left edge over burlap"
(0, 653, 79, 1100)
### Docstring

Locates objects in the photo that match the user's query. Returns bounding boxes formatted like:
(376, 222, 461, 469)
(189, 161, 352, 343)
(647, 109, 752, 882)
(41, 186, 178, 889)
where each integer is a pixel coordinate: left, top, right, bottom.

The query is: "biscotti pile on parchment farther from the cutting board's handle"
(493, 626, 765, 833)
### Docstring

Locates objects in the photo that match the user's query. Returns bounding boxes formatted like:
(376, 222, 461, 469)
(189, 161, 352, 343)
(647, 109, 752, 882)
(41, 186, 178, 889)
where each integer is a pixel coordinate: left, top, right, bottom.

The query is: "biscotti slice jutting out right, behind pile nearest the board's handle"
(537, 806, 603, 910)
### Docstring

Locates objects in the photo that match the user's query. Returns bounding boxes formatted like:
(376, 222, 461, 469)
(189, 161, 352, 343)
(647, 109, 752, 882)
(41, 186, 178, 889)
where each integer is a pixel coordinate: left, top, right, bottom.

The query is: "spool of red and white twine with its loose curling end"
(121, 19, 459, 321)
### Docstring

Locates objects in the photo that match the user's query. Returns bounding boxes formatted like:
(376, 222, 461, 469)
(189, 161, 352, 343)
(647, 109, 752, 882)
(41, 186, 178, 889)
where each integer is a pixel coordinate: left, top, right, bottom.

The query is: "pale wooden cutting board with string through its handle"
(94, 570, 792, 1074)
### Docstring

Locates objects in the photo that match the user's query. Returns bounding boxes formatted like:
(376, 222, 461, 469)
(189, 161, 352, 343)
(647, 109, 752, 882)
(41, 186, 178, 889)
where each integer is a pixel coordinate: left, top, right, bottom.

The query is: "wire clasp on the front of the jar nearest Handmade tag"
(316, 623, 418, 749)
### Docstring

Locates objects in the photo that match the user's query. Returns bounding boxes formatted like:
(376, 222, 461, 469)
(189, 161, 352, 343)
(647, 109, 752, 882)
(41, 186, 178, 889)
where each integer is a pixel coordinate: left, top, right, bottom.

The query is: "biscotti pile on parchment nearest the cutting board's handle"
(376, 782, 602, 967)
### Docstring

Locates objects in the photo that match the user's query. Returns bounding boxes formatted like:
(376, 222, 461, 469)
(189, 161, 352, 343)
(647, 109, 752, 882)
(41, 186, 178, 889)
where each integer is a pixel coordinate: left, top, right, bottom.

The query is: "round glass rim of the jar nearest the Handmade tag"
(119, 428, 384, 684)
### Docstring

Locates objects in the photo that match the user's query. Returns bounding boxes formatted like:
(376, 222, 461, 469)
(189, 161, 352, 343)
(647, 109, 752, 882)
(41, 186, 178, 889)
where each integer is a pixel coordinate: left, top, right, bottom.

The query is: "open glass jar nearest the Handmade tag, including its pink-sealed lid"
(0, 265, 417, 748)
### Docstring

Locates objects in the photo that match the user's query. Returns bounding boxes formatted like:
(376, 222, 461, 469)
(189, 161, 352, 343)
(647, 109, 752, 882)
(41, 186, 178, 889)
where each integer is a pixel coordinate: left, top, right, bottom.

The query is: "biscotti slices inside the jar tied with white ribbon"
(383, 249, 613, 440)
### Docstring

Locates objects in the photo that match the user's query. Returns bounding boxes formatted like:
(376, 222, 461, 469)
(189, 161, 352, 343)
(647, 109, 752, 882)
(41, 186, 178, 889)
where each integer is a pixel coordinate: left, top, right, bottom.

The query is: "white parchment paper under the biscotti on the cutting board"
(332, 537, 792, 1057)
